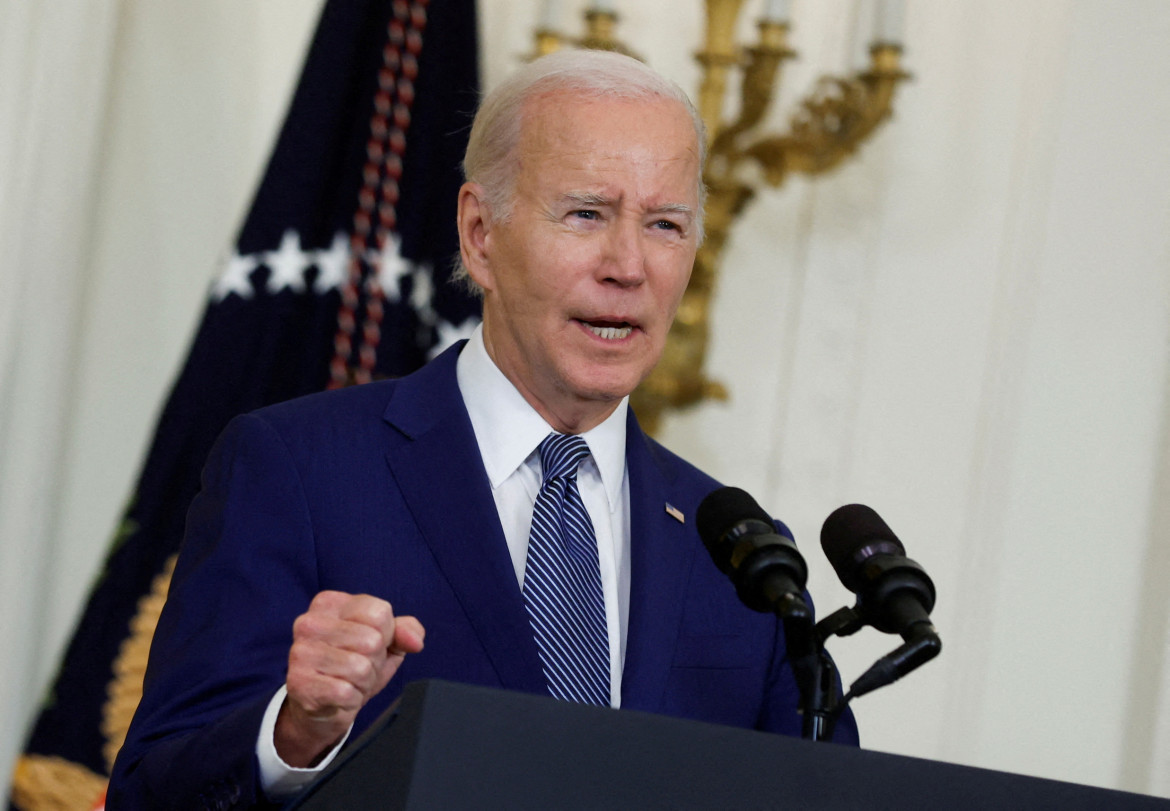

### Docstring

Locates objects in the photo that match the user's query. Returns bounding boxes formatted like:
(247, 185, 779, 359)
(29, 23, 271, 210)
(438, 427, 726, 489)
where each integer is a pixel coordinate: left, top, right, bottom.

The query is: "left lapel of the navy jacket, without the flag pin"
(385, 349, 546, 693)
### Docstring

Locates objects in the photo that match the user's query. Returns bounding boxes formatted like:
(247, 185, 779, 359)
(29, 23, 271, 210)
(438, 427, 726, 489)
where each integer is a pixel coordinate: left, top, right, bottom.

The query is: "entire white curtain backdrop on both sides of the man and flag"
(0, 0, 1170, 796)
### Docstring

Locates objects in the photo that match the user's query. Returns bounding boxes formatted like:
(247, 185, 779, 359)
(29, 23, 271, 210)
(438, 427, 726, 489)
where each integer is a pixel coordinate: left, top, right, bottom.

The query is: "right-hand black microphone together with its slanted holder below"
(820, 504, 942, 706)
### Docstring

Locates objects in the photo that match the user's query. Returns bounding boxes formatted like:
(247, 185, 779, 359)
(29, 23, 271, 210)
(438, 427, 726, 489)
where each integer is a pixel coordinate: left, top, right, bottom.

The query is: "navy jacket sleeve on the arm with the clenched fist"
(109, 415, 318, 809)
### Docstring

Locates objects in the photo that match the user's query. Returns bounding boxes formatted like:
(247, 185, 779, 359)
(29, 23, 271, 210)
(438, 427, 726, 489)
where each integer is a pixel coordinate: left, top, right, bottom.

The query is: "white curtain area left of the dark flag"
(0, 0, 321, 775)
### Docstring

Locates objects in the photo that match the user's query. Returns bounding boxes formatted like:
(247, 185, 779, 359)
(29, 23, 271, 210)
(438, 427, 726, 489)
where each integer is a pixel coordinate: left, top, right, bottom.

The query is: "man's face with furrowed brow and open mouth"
(460, 92, 700, 432)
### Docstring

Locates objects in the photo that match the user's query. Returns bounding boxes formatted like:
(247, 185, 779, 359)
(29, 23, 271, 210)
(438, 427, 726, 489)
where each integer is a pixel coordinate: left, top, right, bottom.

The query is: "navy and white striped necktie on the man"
(523, 433, 610, 706)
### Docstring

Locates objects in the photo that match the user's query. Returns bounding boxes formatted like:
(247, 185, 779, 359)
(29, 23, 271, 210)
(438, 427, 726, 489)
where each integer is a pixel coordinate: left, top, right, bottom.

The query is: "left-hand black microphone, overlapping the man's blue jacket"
(695, 487, 812, 620)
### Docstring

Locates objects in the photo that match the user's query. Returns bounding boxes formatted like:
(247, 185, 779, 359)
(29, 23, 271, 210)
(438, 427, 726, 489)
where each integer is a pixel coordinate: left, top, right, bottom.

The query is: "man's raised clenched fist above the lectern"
(275, 591, 425, 768)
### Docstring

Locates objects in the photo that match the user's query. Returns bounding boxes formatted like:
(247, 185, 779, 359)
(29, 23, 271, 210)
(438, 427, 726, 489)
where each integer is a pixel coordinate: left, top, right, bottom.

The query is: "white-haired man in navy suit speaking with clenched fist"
(110, 51, 856, 807)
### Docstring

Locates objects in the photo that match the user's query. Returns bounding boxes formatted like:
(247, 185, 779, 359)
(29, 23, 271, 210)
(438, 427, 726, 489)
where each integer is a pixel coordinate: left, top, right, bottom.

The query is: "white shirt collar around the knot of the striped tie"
(455, 324, 629, 510)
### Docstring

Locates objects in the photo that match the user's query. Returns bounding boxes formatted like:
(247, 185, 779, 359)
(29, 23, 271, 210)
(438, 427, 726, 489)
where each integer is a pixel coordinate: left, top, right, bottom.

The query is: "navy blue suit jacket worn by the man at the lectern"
(110, 339, 856, 809)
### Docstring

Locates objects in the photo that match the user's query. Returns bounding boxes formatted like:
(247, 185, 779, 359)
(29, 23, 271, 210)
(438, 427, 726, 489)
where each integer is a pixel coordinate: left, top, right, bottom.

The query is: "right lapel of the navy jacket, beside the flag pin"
(621, 411, 697, 712)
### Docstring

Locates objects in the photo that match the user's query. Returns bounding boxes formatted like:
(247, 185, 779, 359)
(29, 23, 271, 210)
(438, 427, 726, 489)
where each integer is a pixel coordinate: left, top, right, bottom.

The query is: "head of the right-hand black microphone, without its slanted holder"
(820, 504, 935, 639)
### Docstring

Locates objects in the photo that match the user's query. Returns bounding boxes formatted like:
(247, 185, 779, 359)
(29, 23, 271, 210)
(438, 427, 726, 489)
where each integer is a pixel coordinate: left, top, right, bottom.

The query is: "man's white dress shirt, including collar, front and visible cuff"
(256, 325, 629, 800)
